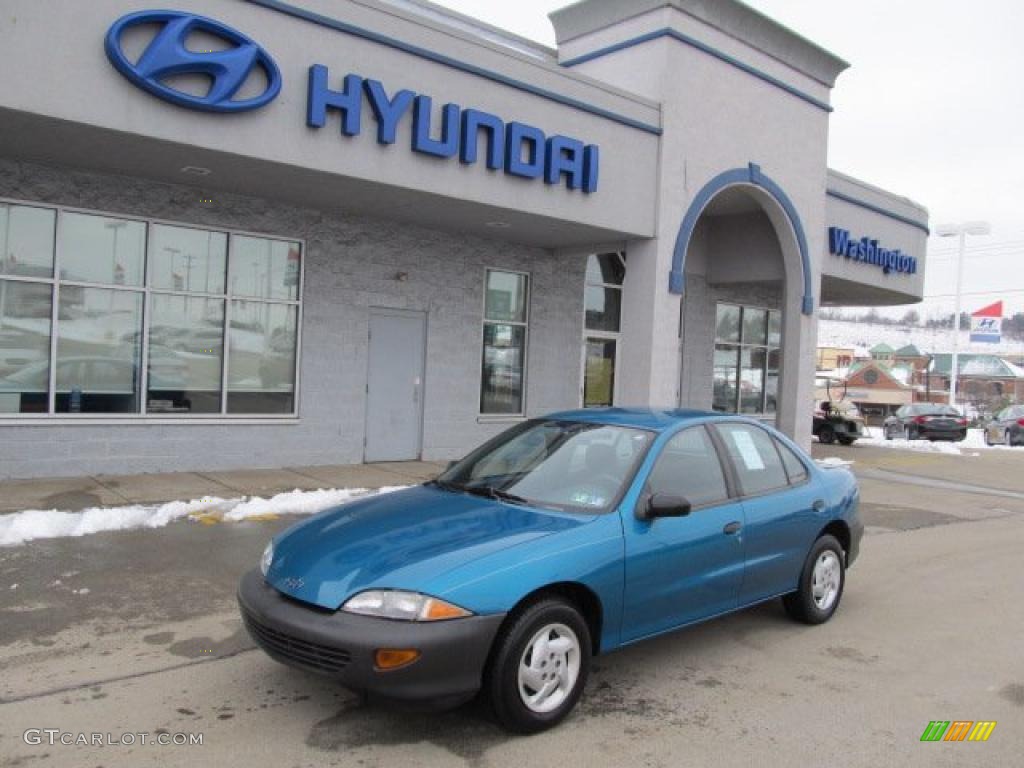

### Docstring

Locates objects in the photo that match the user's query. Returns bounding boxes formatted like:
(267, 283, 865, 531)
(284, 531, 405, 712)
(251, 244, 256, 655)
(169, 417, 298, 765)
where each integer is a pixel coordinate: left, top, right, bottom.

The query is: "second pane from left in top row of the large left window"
(59, 213, 145, 286)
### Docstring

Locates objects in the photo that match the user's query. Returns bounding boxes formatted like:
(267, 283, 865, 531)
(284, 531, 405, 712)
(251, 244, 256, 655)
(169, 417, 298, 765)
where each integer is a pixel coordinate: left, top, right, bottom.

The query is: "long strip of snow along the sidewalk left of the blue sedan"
(0, 485, 406, 547)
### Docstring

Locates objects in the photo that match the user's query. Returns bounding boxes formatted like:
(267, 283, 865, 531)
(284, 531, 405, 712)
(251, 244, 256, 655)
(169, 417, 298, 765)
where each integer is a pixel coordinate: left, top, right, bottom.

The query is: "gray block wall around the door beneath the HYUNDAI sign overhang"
(0, 160, 586, 478)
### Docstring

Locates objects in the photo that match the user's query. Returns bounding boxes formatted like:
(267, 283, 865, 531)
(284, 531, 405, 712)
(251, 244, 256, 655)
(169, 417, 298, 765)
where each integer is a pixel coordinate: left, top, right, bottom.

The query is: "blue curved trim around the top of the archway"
(669, 163, 814, 314)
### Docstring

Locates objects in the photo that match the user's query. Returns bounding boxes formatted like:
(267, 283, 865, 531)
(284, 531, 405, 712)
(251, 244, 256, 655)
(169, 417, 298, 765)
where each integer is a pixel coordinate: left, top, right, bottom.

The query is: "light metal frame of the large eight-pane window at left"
(0, 197, 308, 426)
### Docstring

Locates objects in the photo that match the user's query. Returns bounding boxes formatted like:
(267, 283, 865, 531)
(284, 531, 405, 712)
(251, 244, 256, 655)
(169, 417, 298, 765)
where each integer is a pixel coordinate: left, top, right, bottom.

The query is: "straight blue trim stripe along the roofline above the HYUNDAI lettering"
(247, 0, 662, 136)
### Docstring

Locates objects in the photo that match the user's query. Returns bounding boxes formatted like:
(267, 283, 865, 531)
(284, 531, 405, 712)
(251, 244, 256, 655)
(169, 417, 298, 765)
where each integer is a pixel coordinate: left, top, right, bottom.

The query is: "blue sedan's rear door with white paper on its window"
(715, 423, 825, 605)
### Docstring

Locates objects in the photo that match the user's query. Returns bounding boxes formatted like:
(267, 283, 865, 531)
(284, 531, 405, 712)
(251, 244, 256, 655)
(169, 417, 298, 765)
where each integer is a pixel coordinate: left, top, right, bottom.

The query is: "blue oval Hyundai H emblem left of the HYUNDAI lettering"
(104, 10, 281, 112)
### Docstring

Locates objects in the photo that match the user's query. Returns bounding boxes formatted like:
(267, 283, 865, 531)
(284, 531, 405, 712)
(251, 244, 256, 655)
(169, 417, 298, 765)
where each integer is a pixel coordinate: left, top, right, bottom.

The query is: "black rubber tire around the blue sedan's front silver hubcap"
(483, 598, 592, 733)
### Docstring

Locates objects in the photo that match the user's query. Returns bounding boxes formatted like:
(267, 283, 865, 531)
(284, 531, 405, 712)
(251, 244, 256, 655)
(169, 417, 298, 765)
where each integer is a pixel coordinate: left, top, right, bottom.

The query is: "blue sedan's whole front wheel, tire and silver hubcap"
(484, 598, 591, 733)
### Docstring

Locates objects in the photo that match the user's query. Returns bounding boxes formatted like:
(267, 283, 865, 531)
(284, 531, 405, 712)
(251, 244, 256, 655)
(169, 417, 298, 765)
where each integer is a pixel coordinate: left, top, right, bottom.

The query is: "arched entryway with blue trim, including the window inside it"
(669, 164, 814, 437)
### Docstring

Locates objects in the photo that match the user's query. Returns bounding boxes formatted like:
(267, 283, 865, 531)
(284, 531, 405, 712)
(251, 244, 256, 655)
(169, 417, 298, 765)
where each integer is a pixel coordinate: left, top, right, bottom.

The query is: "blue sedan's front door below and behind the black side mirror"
(623, 426, 743, 642)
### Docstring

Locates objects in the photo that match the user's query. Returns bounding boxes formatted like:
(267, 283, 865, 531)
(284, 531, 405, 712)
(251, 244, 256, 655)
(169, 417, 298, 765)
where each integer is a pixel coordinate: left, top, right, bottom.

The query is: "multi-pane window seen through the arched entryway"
(712, 304, 781, 414)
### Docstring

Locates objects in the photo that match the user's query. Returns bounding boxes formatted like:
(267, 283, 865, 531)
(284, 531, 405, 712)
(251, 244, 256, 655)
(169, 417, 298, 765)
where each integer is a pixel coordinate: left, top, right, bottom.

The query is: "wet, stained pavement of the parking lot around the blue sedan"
(0, 445, 1024, 768)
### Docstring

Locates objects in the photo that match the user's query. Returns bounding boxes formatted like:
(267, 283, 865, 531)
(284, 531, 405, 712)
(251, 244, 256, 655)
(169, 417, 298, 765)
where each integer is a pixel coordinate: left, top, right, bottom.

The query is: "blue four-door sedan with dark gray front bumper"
(239, 409, 863, 733)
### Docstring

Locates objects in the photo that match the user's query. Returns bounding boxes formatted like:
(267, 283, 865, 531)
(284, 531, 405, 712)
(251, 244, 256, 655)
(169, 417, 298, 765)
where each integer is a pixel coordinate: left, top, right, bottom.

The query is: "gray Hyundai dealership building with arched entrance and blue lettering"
(0, 0, 928, 478)
